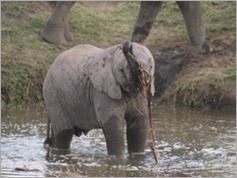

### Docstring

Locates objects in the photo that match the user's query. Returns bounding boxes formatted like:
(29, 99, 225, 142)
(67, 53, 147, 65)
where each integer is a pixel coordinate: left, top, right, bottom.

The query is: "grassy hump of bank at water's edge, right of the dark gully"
(162, 67, 236, 108)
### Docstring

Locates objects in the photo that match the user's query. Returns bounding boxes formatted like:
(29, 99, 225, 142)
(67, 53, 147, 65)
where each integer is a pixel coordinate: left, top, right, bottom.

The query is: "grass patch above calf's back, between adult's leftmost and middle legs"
(69, 2, 138, 47)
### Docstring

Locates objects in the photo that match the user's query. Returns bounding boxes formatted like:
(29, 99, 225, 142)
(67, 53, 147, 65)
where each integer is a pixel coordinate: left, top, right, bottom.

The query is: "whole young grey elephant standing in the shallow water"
(43, 40, 155, 155)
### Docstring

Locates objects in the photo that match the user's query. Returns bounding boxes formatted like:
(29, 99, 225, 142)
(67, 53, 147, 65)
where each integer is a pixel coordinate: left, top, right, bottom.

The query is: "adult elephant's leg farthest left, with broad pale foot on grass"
(41, 1, 75, 44)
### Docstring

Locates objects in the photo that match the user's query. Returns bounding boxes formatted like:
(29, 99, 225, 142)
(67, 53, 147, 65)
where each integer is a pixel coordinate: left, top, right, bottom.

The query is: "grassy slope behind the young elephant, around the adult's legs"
(1, 2, 236, 104)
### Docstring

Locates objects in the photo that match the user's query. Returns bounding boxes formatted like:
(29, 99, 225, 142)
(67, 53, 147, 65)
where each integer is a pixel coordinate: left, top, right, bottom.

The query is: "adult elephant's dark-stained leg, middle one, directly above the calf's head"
(131, 1, 162, 43)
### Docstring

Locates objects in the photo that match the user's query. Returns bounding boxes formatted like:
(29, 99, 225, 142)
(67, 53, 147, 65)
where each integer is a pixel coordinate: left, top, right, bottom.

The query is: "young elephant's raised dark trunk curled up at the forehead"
(122, 41, 143, 92)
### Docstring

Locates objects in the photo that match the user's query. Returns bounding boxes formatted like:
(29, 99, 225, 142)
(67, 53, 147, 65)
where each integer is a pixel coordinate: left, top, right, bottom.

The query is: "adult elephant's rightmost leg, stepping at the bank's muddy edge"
(177, 1, 213, 52)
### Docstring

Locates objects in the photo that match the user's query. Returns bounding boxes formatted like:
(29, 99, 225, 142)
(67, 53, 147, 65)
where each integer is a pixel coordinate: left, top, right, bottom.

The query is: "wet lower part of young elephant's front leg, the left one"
(103, 115, 124, 155)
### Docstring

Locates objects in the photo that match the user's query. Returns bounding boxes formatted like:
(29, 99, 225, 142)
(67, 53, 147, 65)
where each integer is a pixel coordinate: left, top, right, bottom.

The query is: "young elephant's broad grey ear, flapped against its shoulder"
(90, 51, 122, 99)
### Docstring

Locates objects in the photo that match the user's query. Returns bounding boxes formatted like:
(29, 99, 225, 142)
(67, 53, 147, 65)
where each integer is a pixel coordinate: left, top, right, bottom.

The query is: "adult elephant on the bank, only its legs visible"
(41, 1, 213, 52)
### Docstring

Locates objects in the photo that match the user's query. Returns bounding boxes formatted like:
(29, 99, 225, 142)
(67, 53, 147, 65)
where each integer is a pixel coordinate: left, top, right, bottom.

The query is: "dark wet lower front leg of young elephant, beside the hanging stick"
(126, 115, 148, 153)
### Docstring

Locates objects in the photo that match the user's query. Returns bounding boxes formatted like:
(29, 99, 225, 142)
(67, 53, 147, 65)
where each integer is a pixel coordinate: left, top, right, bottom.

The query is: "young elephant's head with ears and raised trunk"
(92, 41, 155, 99)
